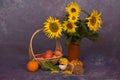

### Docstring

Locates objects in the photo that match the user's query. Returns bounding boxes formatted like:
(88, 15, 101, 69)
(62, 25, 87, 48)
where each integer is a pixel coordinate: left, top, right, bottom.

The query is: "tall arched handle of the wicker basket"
(29, 28, 62, 59)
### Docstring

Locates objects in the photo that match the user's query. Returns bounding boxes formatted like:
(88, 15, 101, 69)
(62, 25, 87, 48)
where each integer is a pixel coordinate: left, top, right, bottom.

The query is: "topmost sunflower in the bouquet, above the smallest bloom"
(66, 2, 81, 15)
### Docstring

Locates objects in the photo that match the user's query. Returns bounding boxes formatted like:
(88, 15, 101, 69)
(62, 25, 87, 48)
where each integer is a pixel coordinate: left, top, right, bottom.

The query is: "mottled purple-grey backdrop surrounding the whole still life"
(0, 0, 120, 80)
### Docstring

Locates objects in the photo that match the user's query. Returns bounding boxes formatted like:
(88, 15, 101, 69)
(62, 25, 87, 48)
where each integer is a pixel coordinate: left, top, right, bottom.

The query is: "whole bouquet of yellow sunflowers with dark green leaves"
(43, 2, 102, 44)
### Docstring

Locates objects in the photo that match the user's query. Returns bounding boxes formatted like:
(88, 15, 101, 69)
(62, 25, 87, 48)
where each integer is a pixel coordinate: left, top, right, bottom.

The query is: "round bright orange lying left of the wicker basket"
(27, 60, 39, 72)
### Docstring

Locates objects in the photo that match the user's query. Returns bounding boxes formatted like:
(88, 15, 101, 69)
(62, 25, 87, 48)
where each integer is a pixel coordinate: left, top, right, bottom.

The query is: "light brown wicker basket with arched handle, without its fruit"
(29, 29, 63, 64)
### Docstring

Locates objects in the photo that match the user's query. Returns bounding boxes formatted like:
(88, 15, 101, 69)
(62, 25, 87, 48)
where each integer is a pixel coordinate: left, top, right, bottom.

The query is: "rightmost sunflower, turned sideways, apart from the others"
(86, 10, 102, 32)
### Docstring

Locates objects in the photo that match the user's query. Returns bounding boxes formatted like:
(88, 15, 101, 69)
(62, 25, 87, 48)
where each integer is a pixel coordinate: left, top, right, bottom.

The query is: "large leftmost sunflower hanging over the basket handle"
(43, 16, 62, 39)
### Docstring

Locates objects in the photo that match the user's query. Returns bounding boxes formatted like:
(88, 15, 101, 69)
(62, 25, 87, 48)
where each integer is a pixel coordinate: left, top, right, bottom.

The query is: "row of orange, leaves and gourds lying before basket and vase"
(27, 58, 84, 75)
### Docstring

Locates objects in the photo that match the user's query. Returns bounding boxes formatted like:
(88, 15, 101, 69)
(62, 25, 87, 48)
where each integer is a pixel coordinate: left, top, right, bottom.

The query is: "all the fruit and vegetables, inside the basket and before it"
(27, 50, 84, 75)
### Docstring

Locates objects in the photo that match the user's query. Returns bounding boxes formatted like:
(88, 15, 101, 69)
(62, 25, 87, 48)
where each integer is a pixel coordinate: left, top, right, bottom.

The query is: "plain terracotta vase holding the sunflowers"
(68, 42, 80, 61)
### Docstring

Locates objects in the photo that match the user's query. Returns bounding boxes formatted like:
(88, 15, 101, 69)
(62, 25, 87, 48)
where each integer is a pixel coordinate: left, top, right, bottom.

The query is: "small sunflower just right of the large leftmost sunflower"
(63, 21, 77, 33)
